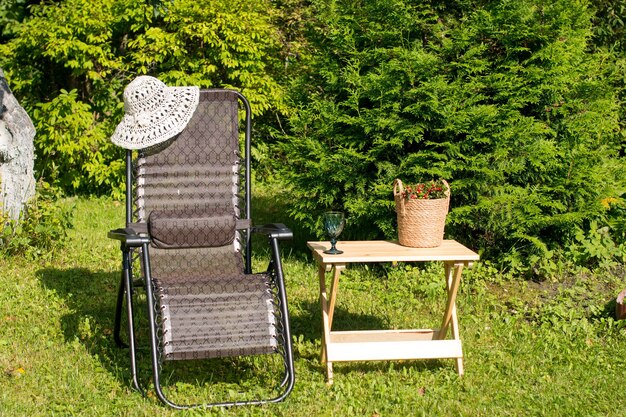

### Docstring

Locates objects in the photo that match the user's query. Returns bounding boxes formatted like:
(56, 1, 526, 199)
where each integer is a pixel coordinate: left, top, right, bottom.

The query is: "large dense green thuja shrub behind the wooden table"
(283, 0, 625, 268)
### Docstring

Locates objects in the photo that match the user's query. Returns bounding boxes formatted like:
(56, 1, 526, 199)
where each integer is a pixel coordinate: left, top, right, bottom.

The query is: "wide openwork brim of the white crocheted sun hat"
(111, 87, 200, 150)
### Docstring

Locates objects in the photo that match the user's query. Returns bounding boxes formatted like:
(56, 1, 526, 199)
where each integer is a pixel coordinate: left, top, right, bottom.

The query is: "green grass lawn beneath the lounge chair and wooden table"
(0, 197, 626, 417)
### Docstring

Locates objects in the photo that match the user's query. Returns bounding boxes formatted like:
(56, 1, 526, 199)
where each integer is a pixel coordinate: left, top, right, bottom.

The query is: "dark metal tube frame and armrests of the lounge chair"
(108, 89, 295, 409)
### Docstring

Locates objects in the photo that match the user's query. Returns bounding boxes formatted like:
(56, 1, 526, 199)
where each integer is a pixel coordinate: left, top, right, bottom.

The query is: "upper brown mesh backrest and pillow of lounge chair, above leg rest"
(135, 90, 245, 281)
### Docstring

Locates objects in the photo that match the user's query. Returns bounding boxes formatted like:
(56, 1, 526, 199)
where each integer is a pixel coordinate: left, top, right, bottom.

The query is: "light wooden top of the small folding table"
(307, 240, 479, 264)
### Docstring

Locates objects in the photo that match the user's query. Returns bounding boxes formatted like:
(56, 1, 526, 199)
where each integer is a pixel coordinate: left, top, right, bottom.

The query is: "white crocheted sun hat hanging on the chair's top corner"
(111, 75, 200, 149)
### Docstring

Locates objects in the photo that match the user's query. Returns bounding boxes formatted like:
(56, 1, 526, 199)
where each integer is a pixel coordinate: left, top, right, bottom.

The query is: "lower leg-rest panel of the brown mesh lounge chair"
(156, 274, 277, 360)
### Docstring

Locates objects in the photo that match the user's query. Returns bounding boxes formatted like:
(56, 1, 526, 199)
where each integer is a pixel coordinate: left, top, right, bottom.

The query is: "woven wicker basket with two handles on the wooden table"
(393, 179, 450, 248)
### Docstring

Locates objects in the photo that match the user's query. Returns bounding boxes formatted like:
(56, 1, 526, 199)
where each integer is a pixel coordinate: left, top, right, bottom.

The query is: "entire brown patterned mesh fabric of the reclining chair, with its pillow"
(135, 91, 277, 359)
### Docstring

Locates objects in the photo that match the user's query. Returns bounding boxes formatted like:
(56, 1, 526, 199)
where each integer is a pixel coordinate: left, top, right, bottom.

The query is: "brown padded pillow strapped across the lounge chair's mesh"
(148, 210, 236, 249)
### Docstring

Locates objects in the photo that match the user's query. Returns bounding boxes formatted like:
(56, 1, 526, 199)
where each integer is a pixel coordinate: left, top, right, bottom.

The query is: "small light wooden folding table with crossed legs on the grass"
(307, 240, 479, 384)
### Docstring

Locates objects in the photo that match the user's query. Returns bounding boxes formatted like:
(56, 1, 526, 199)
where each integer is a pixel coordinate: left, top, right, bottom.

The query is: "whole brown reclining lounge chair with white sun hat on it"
(108, 76, 294, 408)
